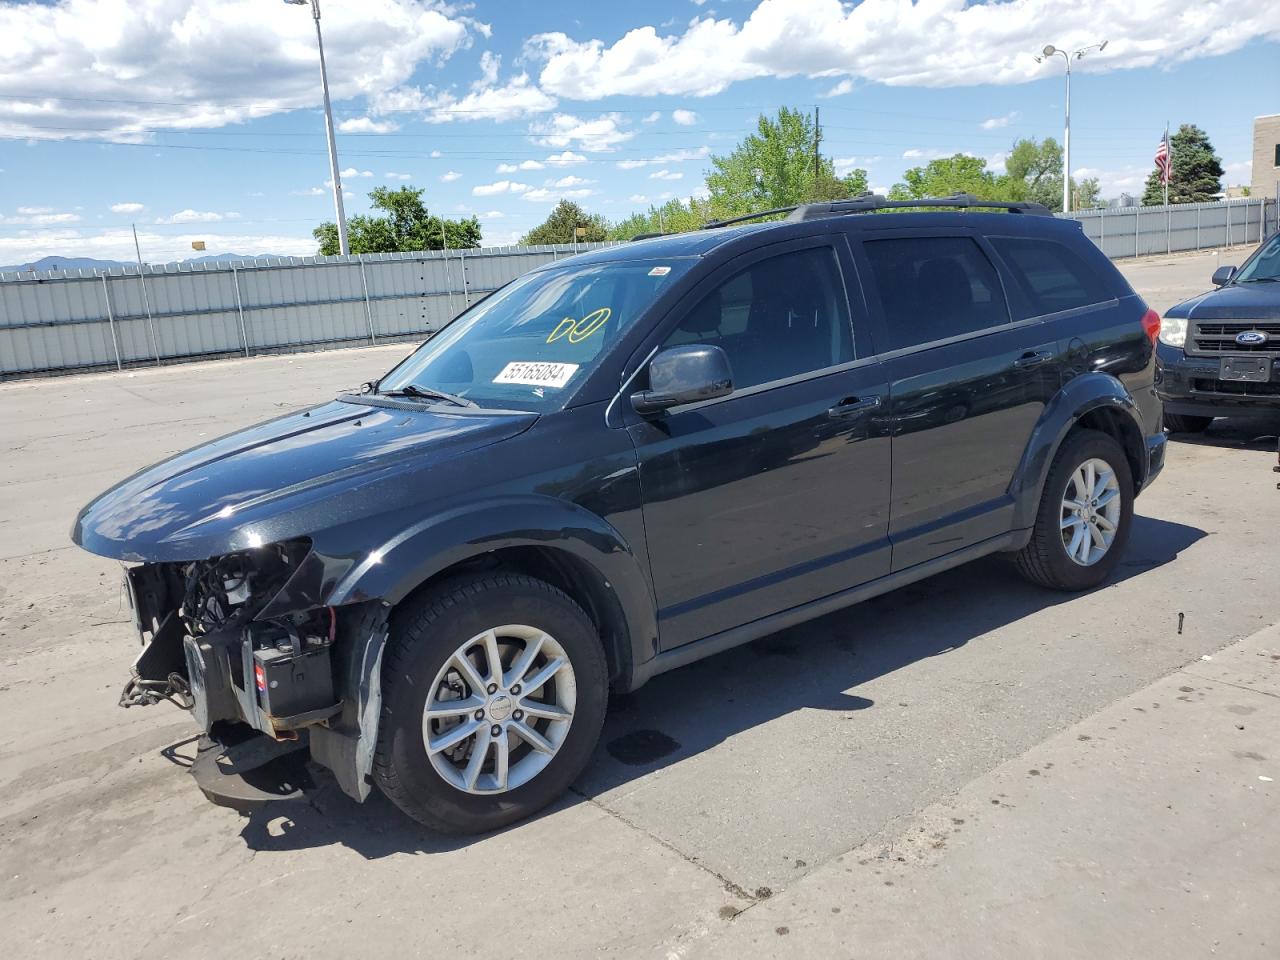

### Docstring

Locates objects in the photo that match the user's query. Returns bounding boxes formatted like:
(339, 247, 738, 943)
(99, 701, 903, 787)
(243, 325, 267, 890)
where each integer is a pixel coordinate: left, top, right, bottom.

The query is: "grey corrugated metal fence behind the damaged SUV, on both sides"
(0, 204, 1277, 378)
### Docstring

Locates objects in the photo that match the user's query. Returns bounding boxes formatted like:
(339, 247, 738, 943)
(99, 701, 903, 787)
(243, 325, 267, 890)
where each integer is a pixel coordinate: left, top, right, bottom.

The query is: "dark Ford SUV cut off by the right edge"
(1156, 233, 1280, 433)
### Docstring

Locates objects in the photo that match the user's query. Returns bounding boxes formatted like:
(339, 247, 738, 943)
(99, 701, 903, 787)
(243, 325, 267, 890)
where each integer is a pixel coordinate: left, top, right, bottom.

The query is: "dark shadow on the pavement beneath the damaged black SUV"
(227, 516, 1206, 859)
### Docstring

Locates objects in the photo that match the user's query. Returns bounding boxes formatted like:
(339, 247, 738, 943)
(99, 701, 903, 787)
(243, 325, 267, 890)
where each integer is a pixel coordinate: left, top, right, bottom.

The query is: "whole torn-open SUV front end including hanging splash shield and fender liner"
(120, 539, 388, 810)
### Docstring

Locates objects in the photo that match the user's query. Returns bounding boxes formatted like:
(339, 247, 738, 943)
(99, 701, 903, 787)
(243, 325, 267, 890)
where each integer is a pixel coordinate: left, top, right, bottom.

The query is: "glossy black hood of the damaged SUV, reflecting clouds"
(72, 399, 538, 562)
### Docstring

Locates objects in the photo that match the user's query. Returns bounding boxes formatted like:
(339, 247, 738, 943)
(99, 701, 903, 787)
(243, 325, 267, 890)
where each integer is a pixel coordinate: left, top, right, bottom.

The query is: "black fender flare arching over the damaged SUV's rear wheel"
(1009, 371, 1146, 530)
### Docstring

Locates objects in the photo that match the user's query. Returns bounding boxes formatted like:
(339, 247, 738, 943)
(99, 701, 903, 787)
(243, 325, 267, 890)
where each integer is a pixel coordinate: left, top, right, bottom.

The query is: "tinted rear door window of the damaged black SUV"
(863, 237, 1009, 352)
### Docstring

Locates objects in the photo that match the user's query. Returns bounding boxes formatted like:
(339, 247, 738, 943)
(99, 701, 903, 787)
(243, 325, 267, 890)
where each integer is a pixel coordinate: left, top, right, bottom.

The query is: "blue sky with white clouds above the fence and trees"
(0, 0, 1280, 264)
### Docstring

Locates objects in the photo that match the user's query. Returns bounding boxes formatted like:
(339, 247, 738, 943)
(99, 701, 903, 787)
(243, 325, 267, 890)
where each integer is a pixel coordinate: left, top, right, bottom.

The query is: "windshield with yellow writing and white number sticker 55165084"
(378, 259, 695, 412)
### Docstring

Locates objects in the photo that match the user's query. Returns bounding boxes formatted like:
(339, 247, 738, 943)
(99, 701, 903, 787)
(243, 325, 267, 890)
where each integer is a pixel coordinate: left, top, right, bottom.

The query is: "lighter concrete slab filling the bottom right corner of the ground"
(690, 627, 1280, 960)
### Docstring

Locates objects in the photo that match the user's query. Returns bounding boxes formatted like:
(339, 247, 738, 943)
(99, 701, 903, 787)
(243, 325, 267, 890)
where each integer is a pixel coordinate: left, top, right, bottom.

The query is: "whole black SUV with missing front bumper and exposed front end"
(73, 197, 1165, 831)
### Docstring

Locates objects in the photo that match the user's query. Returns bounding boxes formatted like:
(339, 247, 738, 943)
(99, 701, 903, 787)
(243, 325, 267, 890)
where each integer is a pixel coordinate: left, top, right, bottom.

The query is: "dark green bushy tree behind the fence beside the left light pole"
(312, 187, 480, 256)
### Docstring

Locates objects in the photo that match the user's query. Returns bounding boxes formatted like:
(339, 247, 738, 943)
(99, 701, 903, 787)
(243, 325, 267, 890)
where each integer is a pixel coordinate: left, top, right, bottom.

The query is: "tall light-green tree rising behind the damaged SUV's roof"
(707, 106, 867, 218)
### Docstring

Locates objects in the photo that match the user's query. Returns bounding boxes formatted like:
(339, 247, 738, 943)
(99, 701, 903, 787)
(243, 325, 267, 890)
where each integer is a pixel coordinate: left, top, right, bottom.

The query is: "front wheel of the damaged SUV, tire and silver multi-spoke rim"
(374, 573, 608, 833)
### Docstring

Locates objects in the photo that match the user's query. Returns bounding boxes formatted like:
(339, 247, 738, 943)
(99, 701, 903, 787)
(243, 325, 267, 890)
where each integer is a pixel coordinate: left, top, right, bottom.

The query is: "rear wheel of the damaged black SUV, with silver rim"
(1014, 430, 1133, 591)
